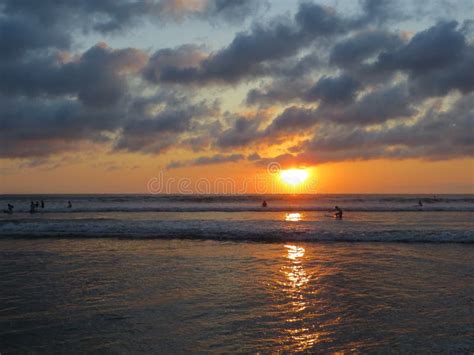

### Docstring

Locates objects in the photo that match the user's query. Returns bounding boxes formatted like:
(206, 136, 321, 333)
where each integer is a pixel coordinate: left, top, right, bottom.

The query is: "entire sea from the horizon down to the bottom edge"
(0, 195, 474, 354)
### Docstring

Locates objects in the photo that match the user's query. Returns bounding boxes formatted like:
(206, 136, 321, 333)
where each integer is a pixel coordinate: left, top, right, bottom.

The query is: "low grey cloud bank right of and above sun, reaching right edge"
(299, 94, 474, 163)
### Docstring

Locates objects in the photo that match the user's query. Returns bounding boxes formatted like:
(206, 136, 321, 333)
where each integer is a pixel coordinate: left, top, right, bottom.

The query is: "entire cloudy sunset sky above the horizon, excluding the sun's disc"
(0, 0, 474, 194)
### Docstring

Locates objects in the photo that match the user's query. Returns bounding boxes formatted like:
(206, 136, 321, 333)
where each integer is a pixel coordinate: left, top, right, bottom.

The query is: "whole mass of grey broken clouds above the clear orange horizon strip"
(0, 0, 474, 166)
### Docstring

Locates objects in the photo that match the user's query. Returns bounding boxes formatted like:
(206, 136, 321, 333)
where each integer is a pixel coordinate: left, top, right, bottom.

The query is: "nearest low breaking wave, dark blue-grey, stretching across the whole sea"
(0, 219, 474, 243)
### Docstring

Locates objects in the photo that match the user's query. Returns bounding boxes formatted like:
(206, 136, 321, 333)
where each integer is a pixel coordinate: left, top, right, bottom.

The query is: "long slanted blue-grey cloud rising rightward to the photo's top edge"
(144, 2, 366, 84)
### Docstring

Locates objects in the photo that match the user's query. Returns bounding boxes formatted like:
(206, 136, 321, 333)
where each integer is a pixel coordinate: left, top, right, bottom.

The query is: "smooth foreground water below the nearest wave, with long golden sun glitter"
(0, 238, 474, 354)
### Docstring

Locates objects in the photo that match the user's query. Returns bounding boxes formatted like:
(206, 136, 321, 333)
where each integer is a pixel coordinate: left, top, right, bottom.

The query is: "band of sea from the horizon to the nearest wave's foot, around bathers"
(0, 195, 474, 243)
